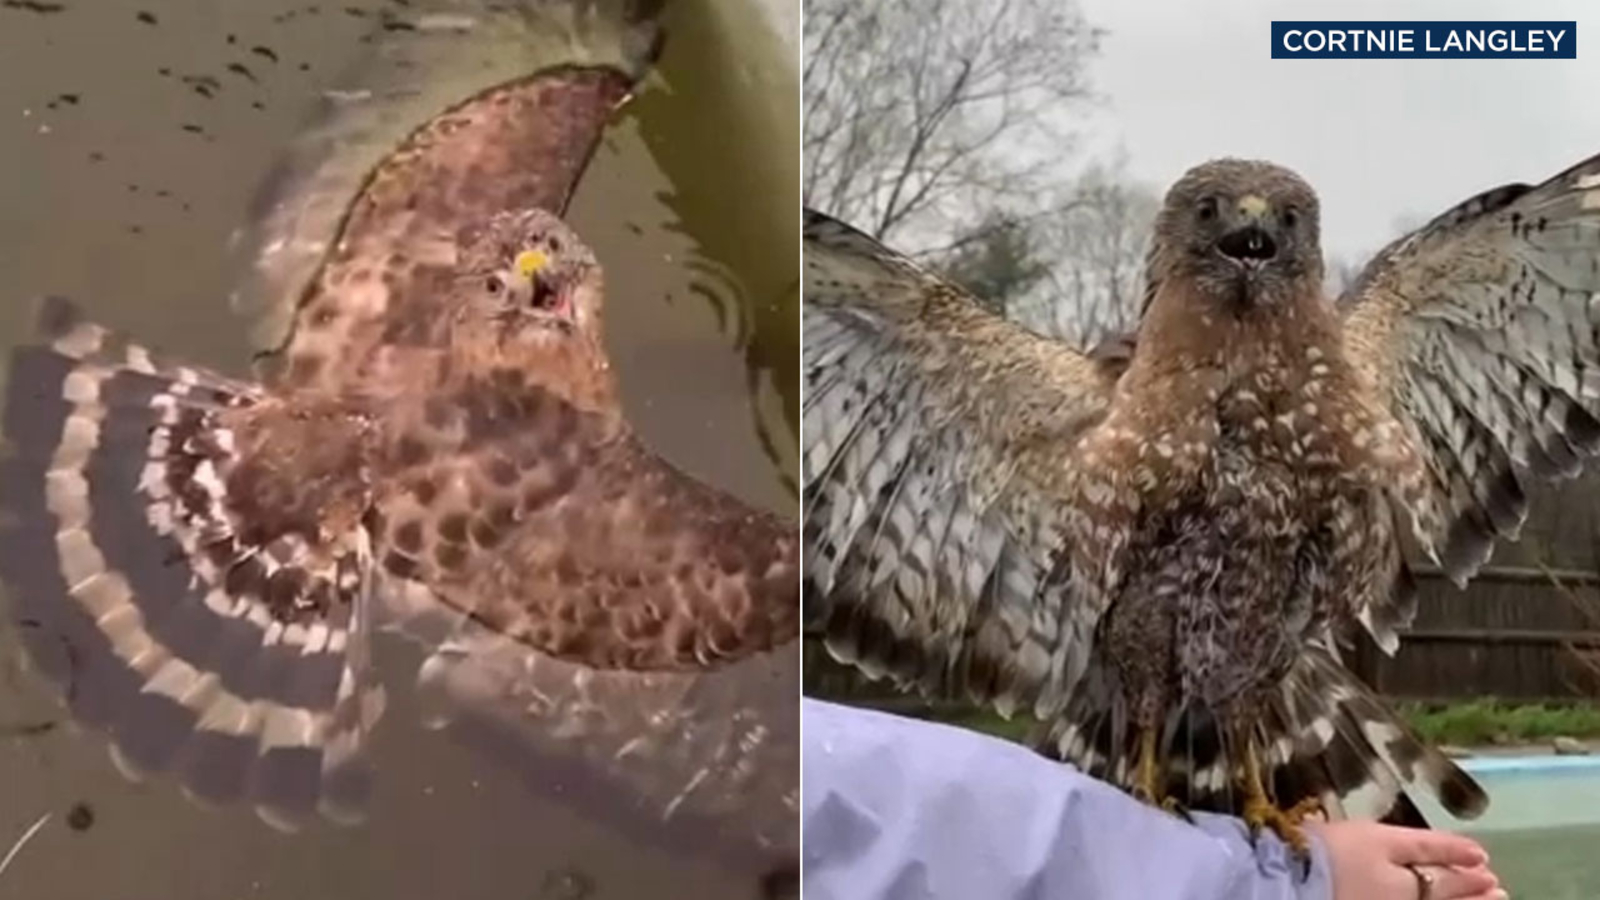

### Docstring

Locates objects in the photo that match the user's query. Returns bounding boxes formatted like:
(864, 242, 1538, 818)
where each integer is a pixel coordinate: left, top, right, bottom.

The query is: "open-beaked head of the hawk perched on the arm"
(1149, 159, 1322, 312)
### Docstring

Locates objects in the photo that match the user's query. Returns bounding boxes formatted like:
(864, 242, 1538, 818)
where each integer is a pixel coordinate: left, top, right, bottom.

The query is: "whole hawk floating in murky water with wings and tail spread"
(0, 12, 800, 855)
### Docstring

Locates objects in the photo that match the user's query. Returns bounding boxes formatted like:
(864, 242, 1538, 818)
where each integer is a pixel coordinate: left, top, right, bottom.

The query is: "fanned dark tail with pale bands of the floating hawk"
(0, 299, 381, 828)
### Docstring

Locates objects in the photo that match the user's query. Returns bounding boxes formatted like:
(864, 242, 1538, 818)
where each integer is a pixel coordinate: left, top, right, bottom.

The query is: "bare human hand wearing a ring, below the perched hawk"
(1307, 822, 1506, 900)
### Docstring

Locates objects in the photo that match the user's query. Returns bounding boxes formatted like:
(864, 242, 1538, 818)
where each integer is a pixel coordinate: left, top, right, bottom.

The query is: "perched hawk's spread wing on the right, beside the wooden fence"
(1342, 157, 1600, 585)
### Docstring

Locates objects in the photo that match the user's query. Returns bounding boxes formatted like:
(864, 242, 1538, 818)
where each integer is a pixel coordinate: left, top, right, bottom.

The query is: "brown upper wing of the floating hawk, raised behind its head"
(269, 67, 632, 389)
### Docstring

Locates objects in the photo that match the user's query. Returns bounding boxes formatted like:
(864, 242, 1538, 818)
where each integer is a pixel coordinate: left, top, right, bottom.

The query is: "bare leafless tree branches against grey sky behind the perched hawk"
(803, 0, 1101, 243)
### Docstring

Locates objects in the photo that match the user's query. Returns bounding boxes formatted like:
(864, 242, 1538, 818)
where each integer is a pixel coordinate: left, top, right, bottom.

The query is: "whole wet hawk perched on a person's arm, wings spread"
(803, 150, 1600, 842)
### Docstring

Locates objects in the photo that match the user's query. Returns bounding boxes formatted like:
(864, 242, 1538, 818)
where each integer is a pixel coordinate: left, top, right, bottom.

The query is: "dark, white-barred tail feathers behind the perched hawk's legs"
(1038, 647, 1488, 828)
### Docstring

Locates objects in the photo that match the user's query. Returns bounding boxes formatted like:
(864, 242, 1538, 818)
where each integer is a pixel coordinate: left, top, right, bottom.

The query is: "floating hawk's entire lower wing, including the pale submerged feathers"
(374, 349, 800, 866)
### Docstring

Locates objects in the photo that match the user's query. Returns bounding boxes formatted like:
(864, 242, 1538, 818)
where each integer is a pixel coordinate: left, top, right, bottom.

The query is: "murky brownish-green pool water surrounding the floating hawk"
(0, 0, 798, 900)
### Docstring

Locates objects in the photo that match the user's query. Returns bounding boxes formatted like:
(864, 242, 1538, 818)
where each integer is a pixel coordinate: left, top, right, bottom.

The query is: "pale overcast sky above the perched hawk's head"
(1078, 0, 1600, 256)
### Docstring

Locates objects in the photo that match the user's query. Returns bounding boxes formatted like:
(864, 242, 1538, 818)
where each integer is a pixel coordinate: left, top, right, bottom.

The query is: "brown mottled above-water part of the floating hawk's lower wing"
(379, 395, 800, 671)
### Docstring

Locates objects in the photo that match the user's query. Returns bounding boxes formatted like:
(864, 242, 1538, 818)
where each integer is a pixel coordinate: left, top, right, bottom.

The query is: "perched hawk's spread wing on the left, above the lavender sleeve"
(802, 211, 1114, 711)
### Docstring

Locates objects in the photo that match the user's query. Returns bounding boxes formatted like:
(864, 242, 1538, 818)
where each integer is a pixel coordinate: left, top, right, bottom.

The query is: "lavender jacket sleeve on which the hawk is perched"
(802, 700, 1333, 900)
